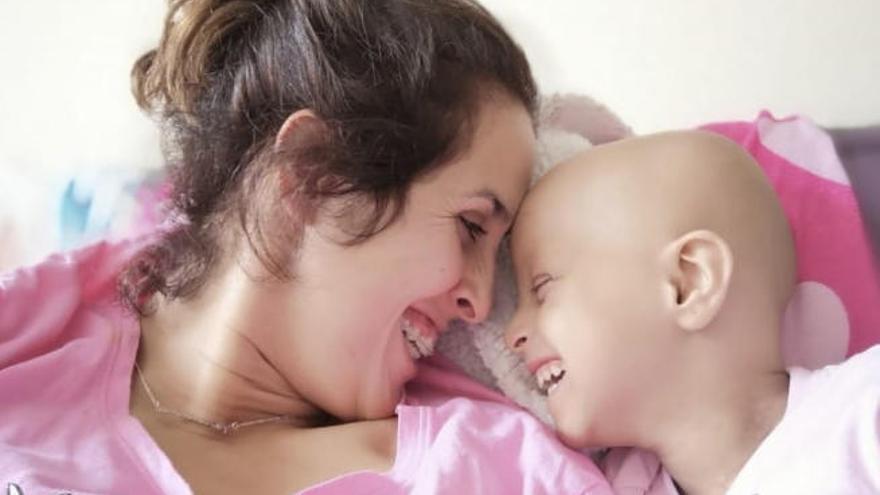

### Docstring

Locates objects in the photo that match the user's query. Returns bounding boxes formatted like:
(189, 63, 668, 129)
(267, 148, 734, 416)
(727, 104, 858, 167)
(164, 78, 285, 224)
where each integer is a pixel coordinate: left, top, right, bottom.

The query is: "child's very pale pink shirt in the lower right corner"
(727, 346, 880, 495)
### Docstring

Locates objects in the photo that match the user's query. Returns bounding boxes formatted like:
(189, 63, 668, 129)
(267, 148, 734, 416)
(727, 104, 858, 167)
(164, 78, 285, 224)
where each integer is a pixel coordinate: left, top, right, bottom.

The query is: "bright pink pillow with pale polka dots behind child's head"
(703, 112, 880, 369)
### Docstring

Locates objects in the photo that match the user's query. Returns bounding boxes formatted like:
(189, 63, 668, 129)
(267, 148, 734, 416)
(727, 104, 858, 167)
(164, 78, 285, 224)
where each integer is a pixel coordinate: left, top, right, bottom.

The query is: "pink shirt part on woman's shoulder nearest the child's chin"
(303, 358, 613, 495)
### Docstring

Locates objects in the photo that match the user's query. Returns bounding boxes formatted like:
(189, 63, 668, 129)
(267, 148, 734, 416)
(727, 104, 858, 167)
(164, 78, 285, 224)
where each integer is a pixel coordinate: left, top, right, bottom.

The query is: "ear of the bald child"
(663, 230, 733, 331)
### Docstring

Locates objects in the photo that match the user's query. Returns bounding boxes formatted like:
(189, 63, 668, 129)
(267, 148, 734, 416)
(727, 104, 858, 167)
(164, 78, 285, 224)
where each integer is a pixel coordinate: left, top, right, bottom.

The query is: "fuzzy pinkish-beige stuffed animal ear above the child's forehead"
(540, 93, 633, 145)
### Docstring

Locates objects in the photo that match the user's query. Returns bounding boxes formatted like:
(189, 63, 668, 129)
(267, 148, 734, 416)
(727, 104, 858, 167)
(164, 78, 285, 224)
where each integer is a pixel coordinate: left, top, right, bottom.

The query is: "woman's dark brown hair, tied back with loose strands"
(120, 0, 536, 314)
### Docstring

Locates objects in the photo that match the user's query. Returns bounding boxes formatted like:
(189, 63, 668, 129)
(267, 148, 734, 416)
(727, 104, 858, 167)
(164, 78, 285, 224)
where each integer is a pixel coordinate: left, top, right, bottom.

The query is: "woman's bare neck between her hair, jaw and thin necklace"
(138, 265, 327, 427)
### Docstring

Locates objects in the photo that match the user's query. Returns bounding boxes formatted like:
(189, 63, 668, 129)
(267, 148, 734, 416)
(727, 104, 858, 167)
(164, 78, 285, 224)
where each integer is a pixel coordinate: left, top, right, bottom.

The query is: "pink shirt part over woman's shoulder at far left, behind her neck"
(0, 238, 189, 495)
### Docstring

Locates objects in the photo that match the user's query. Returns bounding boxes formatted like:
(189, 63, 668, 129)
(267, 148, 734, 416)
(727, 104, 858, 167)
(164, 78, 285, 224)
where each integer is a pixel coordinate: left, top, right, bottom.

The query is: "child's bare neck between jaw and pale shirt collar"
(646, 356, 789, 495)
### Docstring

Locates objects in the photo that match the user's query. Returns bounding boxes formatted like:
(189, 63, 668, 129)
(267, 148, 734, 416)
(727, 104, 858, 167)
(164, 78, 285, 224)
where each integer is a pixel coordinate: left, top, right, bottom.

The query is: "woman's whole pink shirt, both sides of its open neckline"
(0, 241, 611, 495)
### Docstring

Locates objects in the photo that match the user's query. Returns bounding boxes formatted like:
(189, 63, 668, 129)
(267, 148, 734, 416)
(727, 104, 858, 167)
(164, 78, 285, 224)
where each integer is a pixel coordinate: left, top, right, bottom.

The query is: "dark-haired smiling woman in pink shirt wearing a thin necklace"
(0, 0, 604, 494)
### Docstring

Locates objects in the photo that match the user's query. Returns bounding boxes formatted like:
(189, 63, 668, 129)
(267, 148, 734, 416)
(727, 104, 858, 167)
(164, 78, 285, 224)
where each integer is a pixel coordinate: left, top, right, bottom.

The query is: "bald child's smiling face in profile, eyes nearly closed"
(506, 162, 670, 448)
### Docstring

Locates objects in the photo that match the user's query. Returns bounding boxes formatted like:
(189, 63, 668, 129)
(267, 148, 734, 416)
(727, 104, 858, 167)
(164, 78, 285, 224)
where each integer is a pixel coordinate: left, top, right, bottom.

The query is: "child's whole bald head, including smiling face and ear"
(506, 131, 794, 448)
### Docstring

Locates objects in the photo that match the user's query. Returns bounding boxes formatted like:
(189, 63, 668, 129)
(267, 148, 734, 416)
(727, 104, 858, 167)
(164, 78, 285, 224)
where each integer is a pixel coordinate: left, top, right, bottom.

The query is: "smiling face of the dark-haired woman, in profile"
(265, 96, 535, 419)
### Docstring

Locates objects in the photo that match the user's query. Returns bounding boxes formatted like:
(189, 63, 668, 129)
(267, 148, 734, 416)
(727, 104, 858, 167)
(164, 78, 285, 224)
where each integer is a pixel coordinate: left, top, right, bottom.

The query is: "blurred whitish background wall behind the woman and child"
(0, 0, 880, 269)
